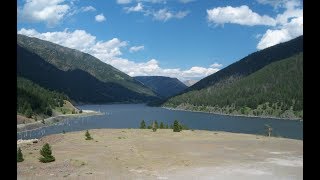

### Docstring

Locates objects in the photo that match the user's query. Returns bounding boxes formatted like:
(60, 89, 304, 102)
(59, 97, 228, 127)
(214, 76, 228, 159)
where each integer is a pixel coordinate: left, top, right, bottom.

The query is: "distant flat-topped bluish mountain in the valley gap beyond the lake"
(134, 76, 187, 98)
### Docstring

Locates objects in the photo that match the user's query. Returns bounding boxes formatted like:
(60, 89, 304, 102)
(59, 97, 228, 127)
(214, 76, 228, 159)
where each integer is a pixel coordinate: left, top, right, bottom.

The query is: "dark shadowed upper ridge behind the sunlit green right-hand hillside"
(185, 35, 303, 92)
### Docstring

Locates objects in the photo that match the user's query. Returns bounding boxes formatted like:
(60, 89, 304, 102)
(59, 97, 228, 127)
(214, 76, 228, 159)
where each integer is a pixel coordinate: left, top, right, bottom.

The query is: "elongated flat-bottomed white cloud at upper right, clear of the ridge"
(207, 5, 276, 26)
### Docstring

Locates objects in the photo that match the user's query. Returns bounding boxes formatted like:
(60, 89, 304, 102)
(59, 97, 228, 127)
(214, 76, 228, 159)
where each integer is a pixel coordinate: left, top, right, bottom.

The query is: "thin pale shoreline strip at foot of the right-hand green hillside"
(160, 106, 303, 122)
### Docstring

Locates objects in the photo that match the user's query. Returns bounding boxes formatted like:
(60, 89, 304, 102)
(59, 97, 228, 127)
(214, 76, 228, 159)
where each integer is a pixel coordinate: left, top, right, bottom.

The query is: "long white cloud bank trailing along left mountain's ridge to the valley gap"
(18, 28, 222, 81)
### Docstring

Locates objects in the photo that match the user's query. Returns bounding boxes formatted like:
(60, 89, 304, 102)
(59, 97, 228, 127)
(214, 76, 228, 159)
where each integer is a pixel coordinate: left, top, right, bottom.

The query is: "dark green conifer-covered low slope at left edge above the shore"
(17, 76, 69, 118)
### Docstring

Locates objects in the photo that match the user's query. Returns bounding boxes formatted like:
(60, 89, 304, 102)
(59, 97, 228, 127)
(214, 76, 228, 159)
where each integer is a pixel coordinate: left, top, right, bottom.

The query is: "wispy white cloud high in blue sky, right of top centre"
(152, 9, 189, 22)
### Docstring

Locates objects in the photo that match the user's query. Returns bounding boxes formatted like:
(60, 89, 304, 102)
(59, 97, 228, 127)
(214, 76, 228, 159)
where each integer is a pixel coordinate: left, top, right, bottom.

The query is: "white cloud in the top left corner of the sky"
(18, 0, 70, 27)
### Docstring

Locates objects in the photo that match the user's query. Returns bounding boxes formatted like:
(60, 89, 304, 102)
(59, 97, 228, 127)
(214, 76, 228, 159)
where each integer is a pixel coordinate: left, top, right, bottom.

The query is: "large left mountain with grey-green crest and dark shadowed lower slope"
(17, 34, 158, 103)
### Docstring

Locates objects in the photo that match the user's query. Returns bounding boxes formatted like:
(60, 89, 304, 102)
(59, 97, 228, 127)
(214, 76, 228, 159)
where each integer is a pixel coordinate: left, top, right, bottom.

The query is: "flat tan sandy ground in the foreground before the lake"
(17, 129, 303, 180)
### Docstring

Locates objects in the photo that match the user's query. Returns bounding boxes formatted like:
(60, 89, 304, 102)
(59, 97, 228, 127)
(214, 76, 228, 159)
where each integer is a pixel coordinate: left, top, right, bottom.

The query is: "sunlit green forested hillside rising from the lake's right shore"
(163, 53, 303, 118)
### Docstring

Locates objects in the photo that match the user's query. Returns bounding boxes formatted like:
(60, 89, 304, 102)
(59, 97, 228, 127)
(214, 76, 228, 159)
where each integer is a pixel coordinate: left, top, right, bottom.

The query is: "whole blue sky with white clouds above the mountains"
(17, 0, 303, 81)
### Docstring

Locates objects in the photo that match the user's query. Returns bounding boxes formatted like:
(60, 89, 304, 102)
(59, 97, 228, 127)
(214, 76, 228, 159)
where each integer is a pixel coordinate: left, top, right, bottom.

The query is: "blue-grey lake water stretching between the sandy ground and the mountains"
(17, 104, 303, 139)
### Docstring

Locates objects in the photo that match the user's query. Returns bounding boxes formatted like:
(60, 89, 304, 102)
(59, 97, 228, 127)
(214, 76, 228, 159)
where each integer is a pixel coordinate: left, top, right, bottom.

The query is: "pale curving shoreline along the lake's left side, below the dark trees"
(17, 110, 104, 133)
